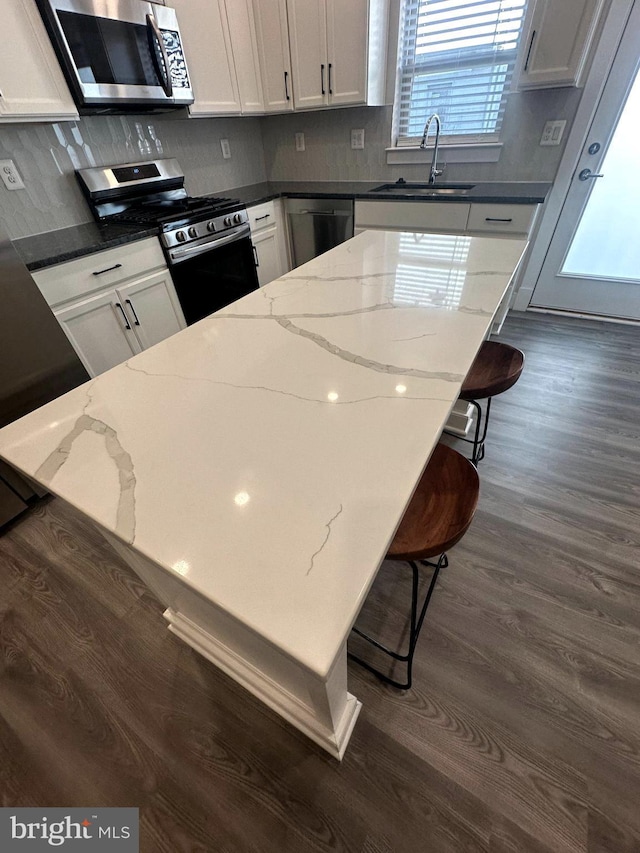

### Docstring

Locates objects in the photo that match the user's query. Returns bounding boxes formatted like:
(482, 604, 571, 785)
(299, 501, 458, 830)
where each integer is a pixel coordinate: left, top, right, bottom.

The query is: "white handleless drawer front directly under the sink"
(356, 201, 470, 234)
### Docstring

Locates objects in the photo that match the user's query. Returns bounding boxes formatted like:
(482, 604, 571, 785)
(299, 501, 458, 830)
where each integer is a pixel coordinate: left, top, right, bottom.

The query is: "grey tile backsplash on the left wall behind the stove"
(0, 113, 266, 239)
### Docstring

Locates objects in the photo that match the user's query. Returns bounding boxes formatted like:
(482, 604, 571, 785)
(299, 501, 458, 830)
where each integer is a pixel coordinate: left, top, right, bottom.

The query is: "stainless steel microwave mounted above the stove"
(37, 0, 193, 113)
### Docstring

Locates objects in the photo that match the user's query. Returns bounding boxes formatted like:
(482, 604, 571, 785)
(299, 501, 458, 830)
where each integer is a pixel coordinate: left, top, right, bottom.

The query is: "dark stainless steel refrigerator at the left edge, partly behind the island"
(0, 230, 89, 530)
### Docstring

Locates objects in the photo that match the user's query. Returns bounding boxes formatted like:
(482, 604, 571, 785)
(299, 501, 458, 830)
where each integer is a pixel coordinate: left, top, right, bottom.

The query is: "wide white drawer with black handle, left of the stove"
(32, 237, 167, 306)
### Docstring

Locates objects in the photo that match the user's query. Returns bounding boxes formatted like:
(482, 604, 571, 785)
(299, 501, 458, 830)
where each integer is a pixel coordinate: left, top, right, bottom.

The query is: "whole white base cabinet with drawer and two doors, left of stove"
(32, 237, 186, 376)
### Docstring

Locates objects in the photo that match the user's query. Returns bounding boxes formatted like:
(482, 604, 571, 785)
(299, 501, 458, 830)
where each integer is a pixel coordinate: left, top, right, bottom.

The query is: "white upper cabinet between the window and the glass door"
(515, 0, 604, 89)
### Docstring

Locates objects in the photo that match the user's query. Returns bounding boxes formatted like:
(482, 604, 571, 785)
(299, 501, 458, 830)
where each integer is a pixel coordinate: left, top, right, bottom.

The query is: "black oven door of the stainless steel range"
(170, 236, 258, 325)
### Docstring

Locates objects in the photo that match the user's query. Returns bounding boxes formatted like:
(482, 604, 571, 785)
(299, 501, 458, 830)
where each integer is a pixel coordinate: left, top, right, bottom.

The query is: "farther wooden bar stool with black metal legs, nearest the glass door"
(460, 341, 524, 465)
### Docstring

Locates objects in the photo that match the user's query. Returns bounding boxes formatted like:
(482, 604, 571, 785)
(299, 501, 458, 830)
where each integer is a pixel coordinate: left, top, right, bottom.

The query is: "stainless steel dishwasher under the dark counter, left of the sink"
(286, 198, 353, 267)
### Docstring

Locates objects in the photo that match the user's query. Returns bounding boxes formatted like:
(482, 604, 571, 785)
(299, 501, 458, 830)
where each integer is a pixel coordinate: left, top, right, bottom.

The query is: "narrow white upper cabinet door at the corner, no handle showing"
(227, 0, 264, 115)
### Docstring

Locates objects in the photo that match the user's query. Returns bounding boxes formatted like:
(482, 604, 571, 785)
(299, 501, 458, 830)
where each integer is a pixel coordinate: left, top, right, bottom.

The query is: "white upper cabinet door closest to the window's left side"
(326, 0, 369, 106)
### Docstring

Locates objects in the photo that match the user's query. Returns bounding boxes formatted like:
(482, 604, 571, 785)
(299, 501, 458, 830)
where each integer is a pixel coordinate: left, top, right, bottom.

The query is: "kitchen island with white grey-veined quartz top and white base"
(0, 231, 526, 758)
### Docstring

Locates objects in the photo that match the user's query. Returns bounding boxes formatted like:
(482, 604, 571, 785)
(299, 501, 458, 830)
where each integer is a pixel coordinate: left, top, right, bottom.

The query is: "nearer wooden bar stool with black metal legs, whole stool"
(349, 444, 480, 690)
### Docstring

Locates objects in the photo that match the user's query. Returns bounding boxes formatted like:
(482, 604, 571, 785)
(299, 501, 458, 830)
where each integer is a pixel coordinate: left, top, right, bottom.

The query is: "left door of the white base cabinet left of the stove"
(54, 290, 141, 376)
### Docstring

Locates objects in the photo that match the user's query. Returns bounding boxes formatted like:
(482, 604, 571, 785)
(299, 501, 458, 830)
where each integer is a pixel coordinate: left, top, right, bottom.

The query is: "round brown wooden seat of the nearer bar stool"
(387, 444, 480, 560)
